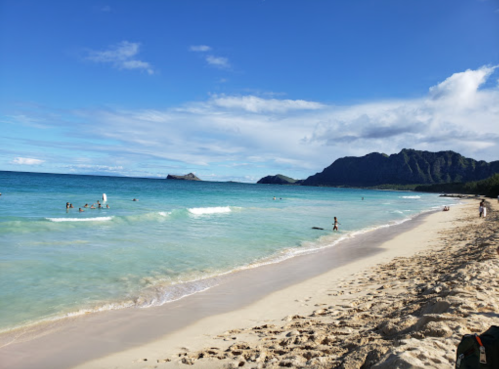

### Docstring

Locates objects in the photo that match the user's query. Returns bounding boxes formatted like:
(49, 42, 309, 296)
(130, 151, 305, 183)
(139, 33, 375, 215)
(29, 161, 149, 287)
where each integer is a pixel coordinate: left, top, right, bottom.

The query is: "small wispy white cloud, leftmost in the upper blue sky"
(86, 41, 154, 74)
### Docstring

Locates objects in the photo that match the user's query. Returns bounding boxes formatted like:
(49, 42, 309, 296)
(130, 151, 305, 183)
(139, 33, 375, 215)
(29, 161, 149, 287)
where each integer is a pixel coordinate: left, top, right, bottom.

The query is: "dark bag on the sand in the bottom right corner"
(456, 325, 499, 369)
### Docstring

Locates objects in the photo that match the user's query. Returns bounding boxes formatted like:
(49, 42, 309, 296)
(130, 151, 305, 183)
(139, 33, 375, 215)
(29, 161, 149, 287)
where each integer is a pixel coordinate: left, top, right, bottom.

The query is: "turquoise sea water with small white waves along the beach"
(0, 172, 458, 330)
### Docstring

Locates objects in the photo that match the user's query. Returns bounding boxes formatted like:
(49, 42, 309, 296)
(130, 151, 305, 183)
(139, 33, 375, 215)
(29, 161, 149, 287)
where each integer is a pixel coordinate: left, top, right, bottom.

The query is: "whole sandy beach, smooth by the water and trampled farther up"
(0, 200, 499, 369)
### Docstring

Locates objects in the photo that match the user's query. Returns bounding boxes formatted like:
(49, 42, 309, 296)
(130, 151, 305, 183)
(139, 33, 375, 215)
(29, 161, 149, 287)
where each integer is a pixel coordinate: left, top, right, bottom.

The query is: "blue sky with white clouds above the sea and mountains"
(0, 0, 499, 183)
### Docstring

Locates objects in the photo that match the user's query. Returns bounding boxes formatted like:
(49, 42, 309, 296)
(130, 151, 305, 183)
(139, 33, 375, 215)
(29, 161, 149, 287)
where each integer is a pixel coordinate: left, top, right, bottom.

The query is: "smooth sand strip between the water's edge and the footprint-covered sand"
(0, 201, 492, 369)
